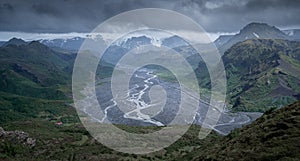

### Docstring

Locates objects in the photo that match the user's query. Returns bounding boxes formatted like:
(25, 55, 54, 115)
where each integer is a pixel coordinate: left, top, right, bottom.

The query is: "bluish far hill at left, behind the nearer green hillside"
(0, 41, 70, 86)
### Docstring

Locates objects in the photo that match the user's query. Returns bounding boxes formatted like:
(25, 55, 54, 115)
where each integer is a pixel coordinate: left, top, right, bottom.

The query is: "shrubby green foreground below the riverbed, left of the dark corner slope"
(0, 119, 219, 161)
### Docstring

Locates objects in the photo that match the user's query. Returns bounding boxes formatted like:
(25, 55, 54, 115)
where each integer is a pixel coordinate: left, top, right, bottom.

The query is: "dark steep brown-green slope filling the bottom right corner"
(188, 101, 300, 161)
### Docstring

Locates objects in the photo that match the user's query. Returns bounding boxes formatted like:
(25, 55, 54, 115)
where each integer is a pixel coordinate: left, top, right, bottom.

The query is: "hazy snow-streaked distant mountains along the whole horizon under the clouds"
(0, 23, 300, 53)
